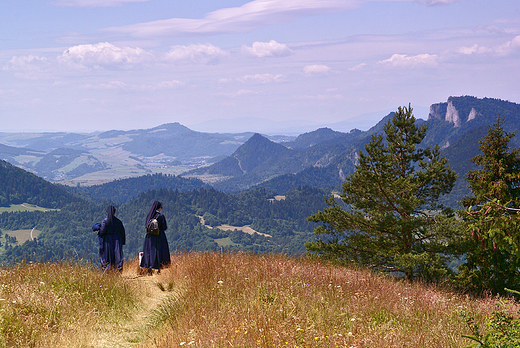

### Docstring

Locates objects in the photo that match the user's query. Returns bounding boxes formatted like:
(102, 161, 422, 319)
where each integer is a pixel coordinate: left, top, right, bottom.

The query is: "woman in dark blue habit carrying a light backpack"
(140, 201, 171, 274)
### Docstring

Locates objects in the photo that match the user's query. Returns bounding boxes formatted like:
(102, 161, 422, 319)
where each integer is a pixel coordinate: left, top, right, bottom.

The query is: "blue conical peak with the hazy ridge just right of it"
(186, 130, 366, 193)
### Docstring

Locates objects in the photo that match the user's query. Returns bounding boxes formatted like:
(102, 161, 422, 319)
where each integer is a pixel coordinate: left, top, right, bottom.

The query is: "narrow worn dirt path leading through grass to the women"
(88, 272, 176, 348)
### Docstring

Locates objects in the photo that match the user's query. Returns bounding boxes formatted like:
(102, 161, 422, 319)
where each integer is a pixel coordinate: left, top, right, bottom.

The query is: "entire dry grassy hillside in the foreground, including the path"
(0, 253, 516, 348)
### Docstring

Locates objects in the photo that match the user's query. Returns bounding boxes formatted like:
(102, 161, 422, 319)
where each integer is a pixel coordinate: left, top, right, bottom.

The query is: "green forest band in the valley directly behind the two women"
(0, 187, 326, 263)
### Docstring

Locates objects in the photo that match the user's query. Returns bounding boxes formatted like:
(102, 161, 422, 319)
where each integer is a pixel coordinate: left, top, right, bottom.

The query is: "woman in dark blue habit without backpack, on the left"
(98, 205, 126, 272)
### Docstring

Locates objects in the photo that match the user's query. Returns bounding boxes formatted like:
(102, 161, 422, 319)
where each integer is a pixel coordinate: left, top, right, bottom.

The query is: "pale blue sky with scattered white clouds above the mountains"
(0, 0, 520, 134)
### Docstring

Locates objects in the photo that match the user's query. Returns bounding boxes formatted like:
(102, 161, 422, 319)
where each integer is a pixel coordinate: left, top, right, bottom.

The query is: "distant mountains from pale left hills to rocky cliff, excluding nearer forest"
(0, 96, 520, 204)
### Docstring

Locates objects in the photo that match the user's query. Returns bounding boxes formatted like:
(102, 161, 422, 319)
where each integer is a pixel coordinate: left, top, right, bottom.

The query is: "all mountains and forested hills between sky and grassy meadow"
(0, 97, 520, 262)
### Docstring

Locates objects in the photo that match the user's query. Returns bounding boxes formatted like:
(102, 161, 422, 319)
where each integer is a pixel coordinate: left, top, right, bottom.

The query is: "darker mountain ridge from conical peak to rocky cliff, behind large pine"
(183, 96, 520, 201)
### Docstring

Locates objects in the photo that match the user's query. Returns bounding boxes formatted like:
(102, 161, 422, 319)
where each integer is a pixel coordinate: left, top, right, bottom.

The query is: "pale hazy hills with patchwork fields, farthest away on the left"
(0, 123, 258, 186)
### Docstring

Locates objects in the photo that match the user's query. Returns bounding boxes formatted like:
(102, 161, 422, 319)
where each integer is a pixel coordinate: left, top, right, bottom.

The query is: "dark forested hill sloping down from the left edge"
(0, 160, 79, 209)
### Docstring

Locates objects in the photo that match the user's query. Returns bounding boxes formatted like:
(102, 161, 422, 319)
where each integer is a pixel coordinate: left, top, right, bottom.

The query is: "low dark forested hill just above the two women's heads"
(77, 173, 210, 203)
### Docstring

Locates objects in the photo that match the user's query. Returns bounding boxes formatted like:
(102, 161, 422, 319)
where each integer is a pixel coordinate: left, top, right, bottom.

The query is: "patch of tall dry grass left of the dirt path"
(0, 262, 138, 347)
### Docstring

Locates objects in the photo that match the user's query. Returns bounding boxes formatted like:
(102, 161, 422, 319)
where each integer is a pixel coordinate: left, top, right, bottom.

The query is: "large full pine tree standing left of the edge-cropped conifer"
(306, 106, 457, 280)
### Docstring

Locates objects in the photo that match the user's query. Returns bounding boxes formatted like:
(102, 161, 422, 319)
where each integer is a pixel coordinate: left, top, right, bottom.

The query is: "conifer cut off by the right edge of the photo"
(459, 117, 520, 293)
